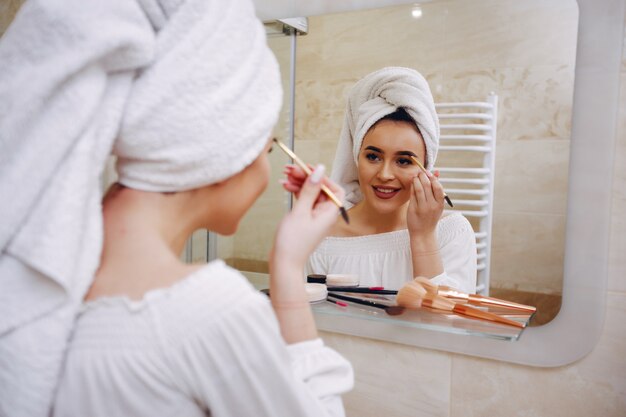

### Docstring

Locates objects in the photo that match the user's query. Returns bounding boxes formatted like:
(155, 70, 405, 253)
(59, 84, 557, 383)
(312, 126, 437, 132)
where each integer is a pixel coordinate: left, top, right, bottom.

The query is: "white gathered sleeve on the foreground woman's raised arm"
(163, 288, 353, 417)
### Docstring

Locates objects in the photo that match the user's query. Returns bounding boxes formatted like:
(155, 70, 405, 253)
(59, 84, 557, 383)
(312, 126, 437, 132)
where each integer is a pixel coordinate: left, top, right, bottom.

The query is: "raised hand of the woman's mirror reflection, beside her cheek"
(407, 172, 445, 240)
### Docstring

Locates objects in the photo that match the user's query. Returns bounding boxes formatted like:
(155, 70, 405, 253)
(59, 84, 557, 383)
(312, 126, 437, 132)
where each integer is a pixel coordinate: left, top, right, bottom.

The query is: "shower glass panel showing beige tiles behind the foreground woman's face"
(184, 22, 296, 288)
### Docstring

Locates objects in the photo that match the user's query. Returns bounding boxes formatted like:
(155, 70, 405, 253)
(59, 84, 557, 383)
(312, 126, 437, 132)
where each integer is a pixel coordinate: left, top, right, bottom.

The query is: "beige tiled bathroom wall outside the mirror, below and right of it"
(322, 4, 626, 417)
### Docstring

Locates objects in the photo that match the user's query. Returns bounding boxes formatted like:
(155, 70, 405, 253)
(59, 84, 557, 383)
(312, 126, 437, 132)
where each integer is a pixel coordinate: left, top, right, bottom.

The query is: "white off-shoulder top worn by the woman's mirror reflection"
(305, 213, 477, 293)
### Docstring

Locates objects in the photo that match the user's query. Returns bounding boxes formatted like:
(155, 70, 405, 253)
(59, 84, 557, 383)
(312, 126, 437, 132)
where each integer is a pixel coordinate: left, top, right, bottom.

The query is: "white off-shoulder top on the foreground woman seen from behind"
(53, 261, 353, 417)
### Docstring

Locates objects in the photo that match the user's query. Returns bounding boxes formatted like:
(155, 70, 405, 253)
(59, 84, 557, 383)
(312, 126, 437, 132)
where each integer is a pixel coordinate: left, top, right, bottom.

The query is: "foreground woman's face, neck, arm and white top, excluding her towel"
(54, 143, 352, 416)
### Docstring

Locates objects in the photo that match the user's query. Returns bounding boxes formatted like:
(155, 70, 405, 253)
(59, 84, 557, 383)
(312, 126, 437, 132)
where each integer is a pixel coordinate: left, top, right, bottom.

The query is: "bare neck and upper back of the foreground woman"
(86, 189, 197, 299)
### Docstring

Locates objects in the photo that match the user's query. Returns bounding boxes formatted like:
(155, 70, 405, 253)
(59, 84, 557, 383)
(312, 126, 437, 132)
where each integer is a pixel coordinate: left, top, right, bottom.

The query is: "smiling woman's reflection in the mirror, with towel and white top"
(285, 67, 476, 293)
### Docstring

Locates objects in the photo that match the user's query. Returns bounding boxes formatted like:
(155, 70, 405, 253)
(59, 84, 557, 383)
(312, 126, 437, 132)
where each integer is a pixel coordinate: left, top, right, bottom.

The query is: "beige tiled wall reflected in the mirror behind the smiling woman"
(295, 0, 578, 294)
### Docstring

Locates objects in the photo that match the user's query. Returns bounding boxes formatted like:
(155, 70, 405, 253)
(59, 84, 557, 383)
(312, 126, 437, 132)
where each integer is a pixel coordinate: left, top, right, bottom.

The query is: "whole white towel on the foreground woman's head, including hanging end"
(0, 0, 282, 416)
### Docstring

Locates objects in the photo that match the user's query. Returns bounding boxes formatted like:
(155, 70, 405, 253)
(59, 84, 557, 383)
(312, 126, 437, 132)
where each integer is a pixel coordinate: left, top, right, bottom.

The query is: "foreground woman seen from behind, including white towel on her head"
(0, 0, 353, 416)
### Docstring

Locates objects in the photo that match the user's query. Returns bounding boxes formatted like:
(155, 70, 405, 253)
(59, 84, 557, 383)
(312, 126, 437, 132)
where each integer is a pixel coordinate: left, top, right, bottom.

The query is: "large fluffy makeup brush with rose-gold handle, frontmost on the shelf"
(396, 281, 525, 329)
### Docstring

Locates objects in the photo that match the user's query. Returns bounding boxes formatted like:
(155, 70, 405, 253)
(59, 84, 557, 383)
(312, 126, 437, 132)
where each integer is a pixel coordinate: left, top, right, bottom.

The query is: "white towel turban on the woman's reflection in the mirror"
(331, 67, 439, 207)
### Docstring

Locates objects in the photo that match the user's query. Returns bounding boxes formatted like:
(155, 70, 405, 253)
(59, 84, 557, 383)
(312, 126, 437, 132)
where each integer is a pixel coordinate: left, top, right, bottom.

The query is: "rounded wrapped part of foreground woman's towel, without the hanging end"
(113, 0, 282, 191)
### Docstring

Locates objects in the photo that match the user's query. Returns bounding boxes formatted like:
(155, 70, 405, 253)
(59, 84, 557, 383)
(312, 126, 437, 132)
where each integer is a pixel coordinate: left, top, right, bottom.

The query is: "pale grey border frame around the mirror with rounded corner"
(254, 0, 626, 367)
